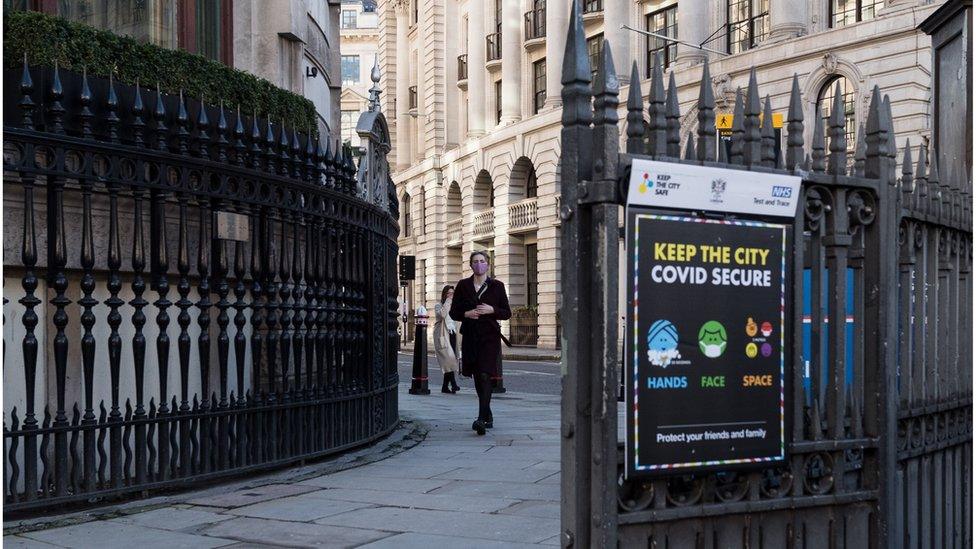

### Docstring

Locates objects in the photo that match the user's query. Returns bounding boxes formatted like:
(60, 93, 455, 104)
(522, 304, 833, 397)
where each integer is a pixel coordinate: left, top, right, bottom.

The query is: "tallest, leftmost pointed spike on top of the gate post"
(561, 0, 593, 127)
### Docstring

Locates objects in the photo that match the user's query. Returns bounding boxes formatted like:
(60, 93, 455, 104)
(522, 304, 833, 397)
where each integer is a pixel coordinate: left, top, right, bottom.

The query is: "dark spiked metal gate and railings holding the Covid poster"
(559, 2, 972, 547)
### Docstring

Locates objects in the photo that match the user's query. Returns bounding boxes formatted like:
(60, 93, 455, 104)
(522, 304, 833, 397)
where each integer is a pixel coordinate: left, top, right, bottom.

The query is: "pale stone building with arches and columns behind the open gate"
(378, 0, 940, 348)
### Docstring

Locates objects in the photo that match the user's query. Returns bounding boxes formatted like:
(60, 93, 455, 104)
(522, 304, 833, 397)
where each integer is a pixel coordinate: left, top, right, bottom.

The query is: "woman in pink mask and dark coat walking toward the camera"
(450, 252, 512, 435)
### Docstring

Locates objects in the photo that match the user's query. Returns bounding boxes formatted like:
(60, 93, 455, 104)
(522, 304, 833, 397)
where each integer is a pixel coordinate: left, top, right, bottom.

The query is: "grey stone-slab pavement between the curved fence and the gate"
(3, 383, 560, 549)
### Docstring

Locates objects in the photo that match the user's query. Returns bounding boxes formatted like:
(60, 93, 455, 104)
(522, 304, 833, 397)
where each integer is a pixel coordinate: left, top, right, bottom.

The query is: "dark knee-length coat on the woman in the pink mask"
(450, 275, 512, 376)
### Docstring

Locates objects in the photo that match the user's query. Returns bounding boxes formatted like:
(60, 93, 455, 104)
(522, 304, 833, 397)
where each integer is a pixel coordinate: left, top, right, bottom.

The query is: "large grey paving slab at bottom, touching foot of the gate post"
(316, 507, 559, 543)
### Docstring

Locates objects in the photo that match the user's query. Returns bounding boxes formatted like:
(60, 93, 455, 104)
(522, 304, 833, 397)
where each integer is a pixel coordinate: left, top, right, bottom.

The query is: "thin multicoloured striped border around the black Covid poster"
(628, 213, 787, 471)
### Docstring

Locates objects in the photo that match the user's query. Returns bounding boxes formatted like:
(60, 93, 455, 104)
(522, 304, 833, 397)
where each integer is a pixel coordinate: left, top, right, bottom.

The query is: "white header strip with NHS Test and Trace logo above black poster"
(627, 159, 801, 217)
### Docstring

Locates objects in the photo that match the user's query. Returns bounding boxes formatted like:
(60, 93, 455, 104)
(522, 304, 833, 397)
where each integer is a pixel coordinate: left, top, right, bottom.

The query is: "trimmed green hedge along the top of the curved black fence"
(3, 10, 318, 133)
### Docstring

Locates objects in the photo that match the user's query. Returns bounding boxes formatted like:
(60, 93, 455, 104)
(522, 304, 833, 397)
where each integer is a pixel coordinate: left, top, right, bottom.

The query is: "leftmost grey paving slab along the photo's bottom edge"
(21, 522, 233, 549)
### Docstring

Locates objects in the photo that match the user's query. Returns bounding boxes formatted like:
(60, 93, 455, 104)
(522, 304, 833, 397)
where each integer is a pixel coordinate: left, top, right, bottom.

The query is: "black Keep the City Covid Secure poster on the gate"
(625, 212, 790, 475)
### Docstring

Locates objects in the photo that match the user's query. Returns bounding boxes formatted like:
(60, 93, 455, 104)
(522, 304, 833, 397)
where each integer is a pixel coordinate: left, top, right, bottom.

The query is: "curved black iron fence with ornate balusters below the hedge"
(3, 65, 398, 513)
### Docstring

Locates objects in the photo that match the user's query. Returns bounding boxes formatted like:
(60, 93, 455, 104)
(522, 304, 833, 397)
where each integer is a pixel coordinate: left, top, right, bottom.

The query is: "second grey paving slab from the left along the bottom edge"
(197, 517, 391, 549)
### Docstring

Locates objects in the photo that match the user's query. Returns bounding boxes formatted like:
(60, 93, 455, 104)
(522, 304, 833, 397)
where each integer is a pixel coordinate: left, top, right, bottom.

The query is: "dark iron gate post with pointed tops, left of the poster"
(559, 0, 620, 547)
